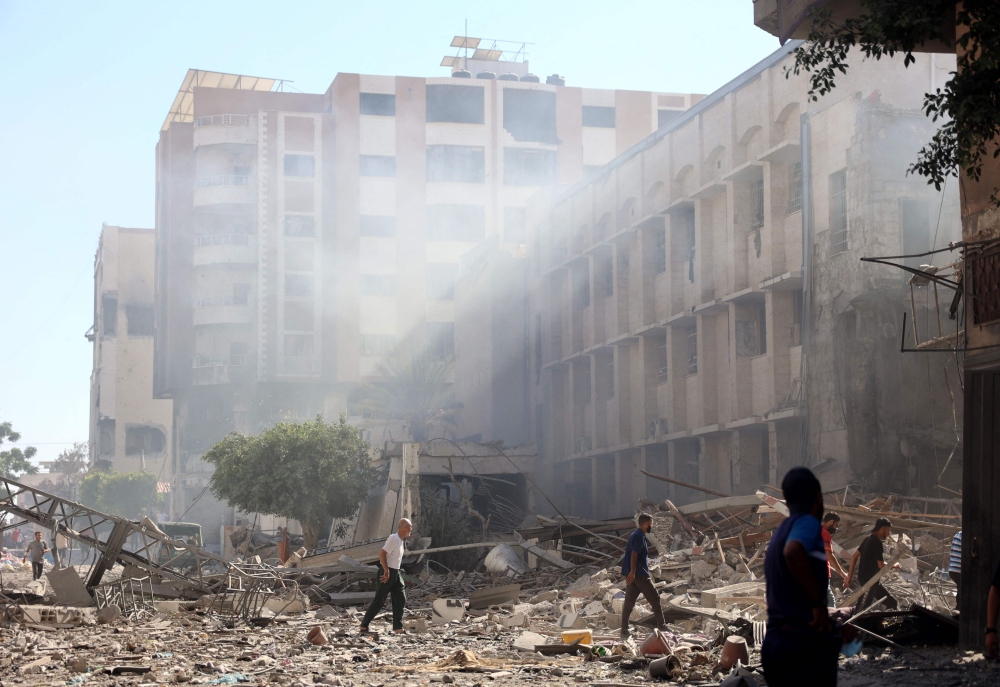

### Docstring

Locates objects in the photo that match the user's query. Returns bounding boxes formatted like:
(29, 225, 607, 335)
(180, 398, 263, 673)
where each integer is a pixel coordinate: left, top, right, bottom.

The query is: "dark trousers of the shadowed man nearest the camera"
(760, 625, 843, 687)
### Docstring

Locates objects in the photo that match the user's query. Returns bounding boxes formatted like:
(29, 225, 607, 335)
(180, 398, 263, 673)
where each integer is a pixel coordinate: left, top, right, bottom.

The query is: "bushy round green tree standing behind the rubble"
(203, 414, 375, 548)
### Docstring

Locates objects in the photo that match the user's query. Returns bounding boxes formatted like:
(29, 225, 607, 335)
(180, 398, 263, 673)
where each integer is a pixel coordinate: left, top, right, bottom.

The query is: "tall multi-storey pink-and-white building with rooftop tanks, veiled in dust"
(153, 51, 699, 544)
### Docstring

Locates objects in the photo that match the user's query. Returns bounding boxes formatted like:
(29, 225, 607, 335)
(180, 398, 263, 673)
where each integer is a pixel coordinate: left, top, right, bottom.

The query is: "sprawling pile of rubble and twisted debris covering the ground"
(0, 480, 960, 685)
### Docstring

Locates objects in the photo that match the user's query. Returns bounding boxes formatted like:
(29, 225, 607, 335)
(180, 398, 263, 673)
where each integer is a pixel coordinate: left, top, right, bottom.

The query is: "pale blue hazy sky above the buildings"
(0, 0, 778, 460)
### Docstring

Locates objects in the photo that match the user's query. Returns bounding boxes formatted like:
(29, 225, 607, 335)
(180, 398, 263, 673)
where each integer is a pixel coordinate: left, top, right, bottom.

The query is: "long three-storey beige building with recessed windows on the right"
(516, 43, 962, 517)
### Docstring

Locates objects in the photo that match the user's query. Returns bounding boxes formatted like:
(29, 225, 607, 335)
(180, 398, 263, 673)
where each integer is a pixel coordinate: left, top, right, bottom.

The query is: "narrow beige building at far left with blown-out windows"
(87, 225, 173, 490)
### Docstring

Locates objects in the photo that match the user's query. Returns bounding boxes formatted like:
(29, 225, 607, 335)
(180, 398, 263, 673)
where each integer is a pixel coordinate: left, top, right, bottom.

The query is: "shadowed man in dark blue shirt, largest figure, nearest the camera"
(761, 467, 843, 687)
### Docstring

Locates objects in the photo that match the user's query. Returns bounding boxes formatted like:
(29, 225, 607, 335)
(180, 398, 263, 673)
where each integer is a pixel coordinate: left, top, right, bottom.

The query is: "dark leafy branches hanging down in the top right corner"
(789, 0, 1000, 198)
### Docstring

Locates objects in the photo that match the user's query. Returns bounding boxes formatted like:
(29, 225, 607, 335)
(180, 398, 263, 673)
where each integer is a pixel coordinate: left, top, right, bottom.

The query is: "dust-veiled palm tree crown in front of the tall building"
(359, 346, 462, 441)
